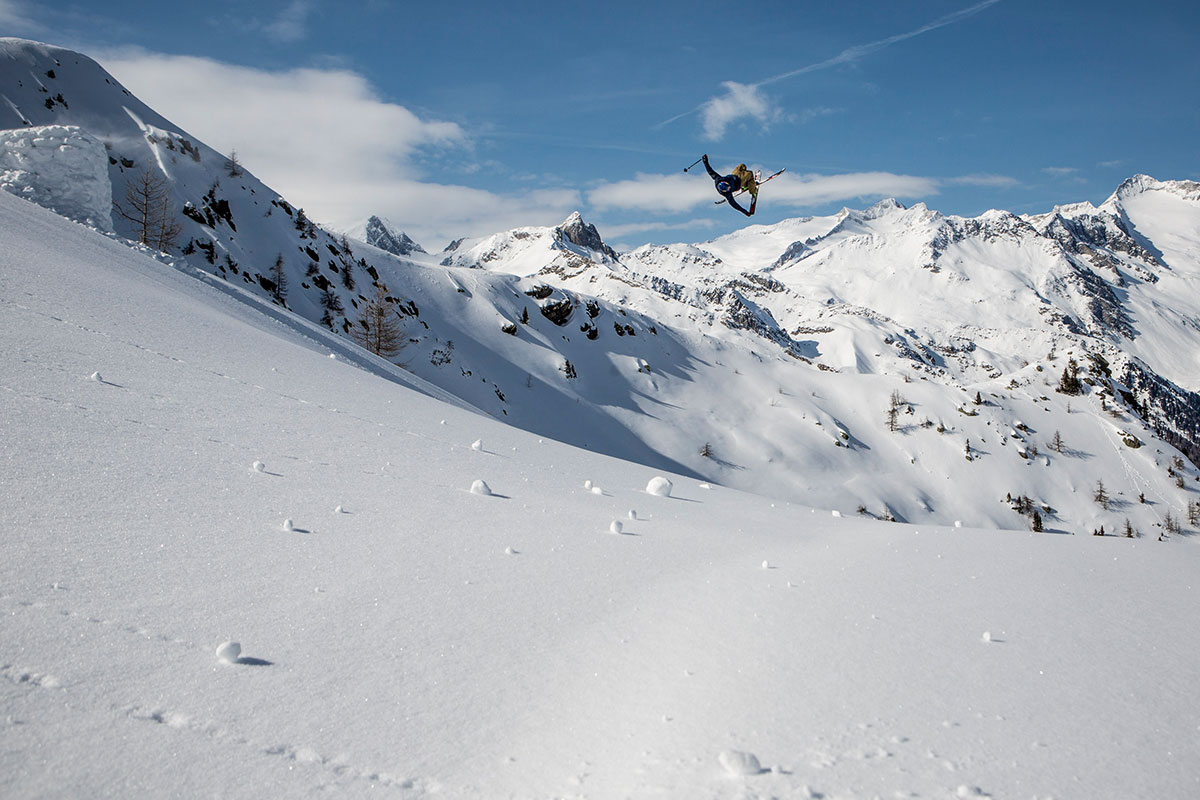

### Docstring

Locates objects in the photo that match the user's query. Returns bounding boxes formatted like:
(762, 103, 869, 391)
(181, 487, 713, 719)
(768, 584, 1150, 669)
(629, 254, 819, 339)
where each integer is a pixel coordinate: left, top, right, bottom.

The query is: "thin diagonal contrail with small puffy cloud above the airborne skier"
(654, 0, 1001, 142)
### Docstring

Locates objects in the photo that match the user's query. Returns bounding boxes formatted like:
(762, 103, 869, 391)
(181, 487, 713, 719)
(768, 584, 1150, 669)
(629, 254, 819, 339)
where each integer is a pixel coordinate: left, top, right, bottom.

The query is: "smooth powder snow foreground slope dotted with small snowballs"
(0, 193, 1200, 799)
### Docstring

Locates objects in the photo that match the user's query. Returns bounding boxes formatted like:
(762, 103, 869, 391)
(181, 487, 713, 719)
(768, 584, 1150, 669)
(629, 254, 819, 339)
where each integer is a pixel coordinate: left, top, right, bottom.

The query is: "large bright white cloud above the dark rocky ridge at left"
(91, 49, 580, 247)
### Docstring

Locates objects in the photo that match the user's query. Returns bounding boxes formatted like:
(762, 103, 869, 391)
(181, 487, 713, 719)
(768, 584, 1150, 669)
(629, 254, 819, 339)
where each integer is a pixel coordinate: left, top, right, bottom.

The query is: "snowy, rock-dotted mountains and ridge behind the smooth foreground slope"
(0, 38, 1200, 535)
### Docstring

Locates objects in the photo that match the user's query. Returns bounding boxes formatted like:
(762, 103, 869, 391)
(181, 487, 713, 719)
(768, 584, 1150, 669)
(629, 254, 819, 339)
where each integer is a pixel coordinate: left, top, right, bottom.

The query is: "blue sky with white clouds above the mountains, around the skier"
(0, 0, 1200, 249)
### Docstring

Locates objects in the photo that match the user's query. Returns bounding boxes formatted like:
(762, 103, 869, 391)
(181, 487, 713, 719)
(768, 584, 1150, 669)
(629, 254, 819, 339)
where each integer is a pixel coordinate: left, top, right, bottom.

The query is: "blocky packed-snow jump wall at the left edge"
(0, 125, 113, 231)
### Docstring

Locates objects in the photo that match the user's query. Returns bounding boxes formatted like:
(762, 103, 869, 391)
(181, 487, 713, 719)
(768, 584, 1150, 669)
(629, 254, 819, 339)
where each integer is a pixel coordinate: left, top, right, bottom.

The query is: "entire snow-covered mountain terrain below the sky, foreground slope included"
(7, 40, 1200, 800)
